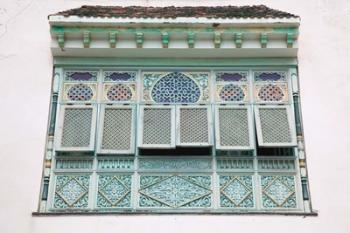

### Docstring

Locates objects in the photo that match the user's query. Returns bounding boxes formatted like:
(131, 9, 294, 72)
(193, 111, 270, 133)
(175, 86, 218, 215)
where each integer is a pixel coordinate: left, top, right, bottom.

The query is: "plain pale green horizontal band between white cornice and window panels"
(54, 57, 297, 68)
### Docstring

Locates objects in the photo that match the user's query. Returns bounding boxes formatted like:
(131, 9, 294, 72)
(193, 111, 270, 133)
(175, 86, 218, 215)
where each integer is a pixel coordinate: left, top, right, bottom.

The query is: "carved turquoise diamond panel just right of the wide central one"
(219, 176, 254, 208)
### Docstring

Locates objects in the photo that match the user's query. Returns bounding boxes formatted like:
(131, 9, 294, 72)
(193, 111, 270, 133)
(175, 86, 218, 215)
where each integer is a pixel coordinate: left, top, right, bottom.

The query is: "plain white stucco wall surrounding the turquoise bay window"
(0, 0, 350, 233)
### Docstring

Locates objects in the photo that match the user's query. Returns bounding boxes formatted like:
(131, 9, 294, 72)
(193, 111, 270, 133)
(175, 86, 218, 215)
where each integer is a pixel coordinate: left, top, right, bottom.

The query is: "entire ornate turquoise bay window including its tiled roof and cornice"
(39, 6, 312, 214)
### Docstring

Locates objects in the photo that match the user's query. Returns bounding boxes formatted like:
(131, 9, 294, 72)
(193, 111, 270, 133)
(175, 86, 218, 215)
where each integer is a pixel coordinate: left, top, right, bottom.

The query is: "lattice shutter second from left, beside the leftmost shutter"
(100, 107, 133, 153)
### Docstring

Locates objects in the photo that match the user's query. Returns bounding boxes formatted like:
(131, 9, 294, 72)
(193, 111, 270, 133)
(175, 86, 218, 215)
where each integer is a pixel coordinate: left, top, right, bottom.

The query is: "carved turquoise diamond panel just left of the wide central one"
(96, 175, 131, 208)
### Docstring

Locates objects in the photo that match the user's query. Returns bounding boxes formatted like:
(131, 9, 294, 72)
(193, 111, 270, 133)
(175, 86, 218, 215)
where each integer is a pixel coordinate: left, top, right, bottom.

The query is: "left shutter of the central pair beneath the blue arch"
(141, 107, 175, 147)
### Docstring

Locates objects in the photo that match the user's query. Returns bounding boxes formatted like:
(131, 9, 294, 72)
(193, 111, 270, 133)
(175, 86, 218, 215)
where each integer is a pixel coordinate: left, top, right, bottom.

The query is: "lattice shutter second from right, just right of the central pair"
(215, 107, 253, 149)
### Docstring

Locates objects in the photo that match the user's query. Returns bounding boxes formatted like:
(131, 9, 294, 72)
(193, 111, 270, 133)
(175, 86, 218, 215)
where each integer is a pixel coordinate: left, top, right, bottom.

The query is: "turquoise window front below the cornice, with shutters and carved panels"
(38, 68, 314, 215)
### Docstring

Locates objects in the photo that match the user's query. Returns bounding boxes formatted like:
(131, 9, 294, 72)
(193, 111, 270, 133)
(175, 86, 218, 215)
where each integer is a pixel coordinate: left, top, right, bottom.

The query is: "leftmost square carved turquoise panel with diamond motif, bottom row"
(53, 175, 90, 209)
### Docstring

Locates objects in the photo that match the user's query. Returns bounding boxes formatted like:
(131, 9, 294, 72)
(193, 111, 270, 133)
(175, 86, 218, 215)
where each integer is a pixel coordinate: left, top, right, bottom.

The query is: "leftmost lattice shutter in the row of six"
(60, 107, 94, 148)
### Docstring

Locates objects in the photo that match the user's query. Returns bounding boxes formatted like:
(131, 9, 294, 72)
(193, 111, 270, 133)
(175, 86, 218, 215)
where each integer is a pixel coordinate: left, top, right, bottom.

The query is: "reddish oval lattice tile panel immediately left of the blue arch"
(105, 83, 135, 101)
